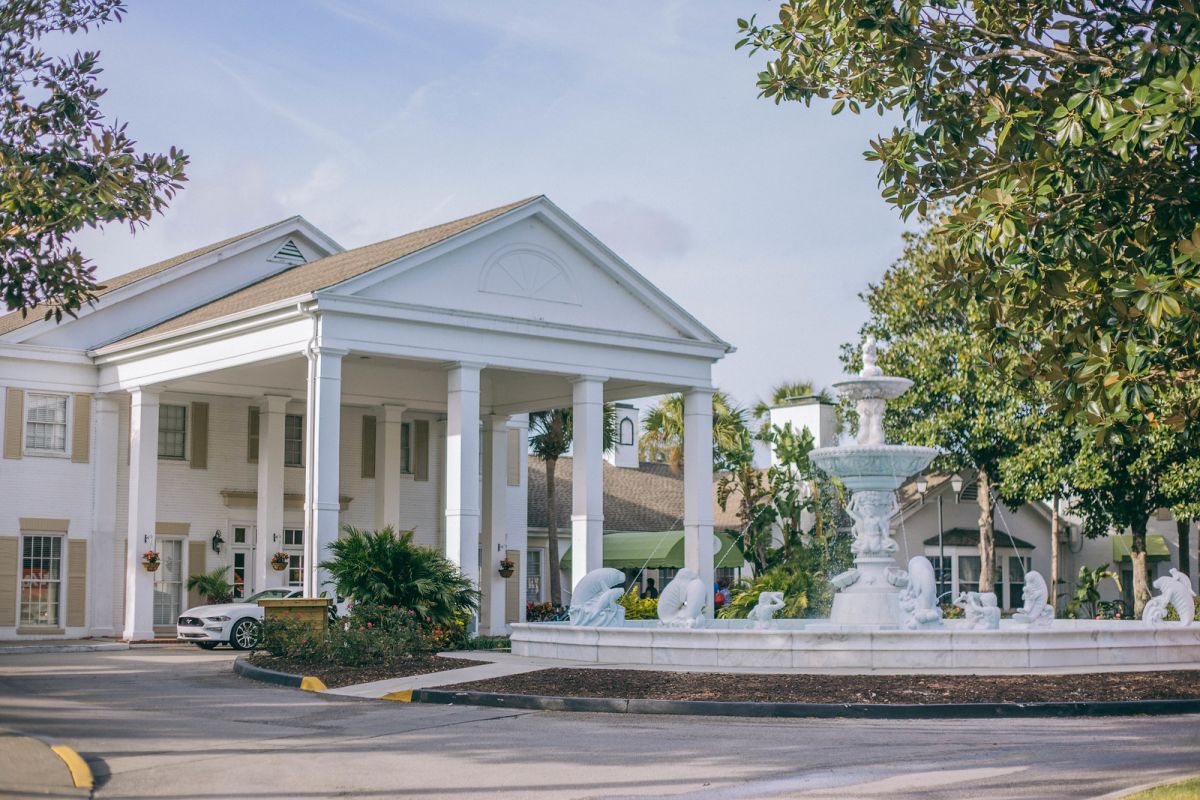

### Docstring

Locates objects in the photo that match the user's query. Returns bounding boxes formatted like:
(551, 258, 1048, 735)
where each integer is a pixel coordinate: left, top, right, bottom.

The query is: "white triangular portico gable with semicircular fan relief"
(318, 196, 732, 350)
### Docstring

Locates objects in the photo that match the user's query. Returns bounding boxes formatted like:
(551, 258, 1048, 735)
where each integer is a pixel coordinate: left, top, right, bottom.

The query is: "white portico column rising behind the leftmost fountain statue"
(571, 377, 605, 590)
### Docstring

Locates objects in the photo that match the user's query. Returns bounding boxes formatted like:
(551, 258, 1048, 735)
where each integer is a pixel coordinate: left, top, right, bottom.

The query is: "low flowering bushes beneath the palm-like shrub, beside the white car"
(259, 603, 467, 667)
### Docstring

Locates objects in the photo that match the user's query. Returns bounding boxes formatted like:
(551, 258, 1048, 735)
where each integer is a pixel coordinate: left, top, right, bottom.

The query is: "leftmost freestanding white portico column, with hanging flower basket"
(88, 395, 120, 636)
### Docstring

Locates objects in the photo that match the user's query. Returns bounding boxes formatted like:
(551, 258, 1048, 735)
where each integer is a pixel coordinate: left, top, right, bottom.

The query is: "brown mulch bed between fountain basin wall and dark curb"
(438, 669, 1200, 703)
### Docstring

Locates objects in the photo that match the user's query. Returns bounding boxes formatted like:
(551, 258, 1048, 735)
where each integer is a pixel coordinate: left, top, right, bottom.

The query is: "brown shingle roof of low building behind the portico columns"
(529, 457, 739, 531)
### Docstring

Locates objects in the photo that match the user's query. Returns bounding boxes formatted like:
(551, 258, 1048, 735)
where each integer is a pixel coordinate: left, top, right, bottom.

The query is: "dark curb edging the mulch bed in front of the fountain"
(405, 688, 1200, 720)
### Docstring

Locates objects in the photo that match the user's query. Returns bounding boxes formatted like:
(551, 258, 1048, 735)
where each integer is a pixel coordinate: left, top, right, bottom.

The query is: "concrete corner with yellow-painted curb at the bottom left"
(0, 729, 92, 798)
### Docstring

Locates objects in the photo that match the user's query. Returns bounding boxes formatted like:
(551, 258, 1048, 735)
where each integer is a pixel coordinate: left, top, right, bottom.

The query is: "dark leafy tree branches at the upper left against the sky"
(0, 0, 187, 320)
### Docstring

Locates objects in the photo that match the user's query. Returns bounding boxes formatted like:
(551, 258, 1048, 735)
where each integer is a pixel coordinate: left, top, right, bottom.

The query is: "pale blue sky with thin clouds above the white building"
(67, 0, 904, 404)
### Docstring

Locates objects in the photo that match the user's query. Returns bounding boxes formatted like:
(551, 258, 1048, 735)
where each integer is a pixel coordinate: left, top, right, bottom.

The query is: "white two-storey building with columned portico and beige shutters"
(0, 197, 731, 640)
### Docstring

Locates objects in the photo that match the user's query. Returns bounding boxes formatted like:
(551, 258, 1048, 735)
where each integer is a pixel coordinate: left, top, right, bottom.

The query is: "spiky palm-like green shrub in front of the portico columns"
(320, 525, 479, 626)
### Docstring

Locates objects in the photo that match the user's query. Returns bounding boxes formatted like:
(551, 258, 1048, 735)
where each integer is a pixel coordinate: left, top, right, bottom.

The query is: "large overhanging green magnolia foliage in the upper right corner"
(737, 0, 1200, 438)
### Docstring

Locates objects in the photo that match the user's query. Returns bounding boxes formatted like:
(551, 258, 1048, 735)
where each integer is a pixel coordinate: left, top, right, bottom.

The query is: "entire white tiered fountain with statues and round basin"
(512, 338, 1200, 673)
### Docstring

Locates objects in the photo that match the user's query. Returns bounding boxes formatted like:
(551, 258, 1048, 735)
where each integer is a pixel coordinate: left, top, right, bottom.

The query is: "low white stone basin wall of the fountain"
(512, 619, 1200, 674)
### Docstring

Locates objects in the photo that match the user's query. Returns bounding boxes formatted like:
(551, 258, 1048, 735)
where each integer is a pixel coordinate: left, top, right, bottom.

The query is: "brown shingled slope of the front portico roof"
(113, 197, 538, 343)
